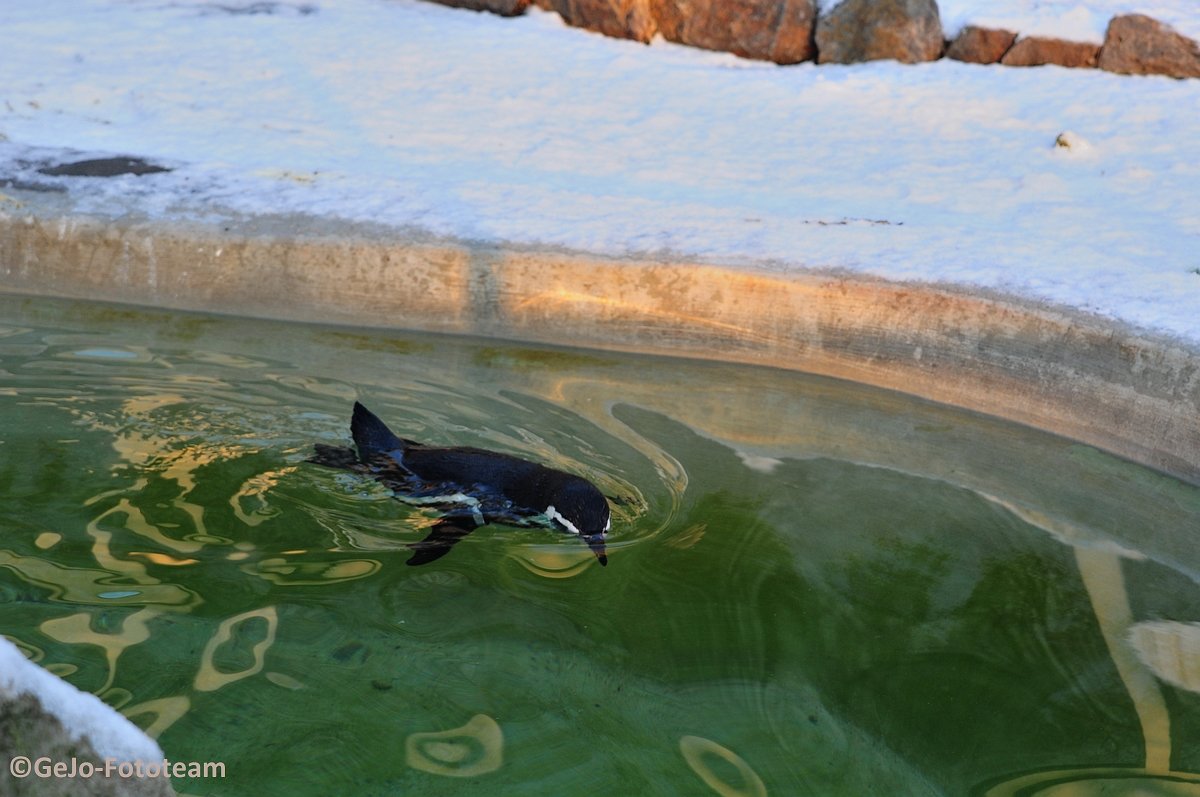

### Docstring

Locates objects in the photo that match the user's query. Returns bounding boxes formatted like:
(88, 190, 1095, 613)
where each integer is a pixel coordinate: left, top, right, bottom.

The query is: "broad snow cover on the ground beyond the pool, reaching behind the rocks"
(0, 0, 1200, 342)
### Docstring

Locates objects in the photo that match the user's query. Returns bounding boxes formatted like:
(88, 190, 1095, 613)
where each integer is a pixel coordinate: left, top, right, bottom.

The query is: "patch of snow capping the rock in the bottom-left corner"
(0, 636, 163, 767)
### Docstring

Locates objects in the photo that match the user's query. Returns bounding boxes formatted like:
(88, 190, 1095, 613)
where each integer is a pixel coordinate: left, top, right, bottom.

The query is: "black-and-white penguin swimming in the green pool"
(307, 401, 612, 565)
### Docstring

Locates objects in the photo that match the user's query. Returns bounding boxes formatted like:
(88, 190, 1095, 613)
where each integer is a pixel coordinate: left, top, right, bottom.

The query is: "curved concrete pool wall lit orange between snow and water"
(0, 200, 1200, 483)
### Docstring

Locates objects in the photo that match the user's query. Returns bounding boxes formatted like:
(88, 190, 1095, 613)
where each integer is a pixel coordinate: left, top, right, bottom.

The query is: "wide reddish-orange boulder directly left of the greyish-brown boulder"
(652, 0, 817, 64)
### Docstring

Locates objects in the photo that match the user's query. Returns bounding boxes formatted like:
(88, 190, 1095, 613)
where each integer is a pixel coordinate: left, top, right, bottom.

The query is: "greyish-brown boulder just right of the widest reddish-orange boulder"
(816, 0, 944, 64)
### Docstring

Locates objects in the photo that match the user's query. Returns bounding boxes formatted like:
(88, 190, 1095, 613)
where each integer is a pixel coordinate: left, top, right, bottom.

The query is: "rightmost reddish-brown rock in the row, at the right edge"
(1099, 14, 1200, 78)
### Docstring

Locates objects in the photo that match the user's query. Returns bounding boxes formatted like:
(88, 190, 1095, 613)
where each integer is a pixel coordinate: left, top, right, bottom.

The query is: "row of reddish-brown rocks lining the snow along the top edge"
(434, 0, 1200, 78)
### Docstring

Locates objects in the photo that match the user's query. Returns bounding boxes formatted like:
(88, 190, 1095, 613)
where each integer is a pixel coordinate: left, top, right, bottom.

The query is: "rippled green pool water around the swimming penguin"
(0, 298, 1200, 796)
